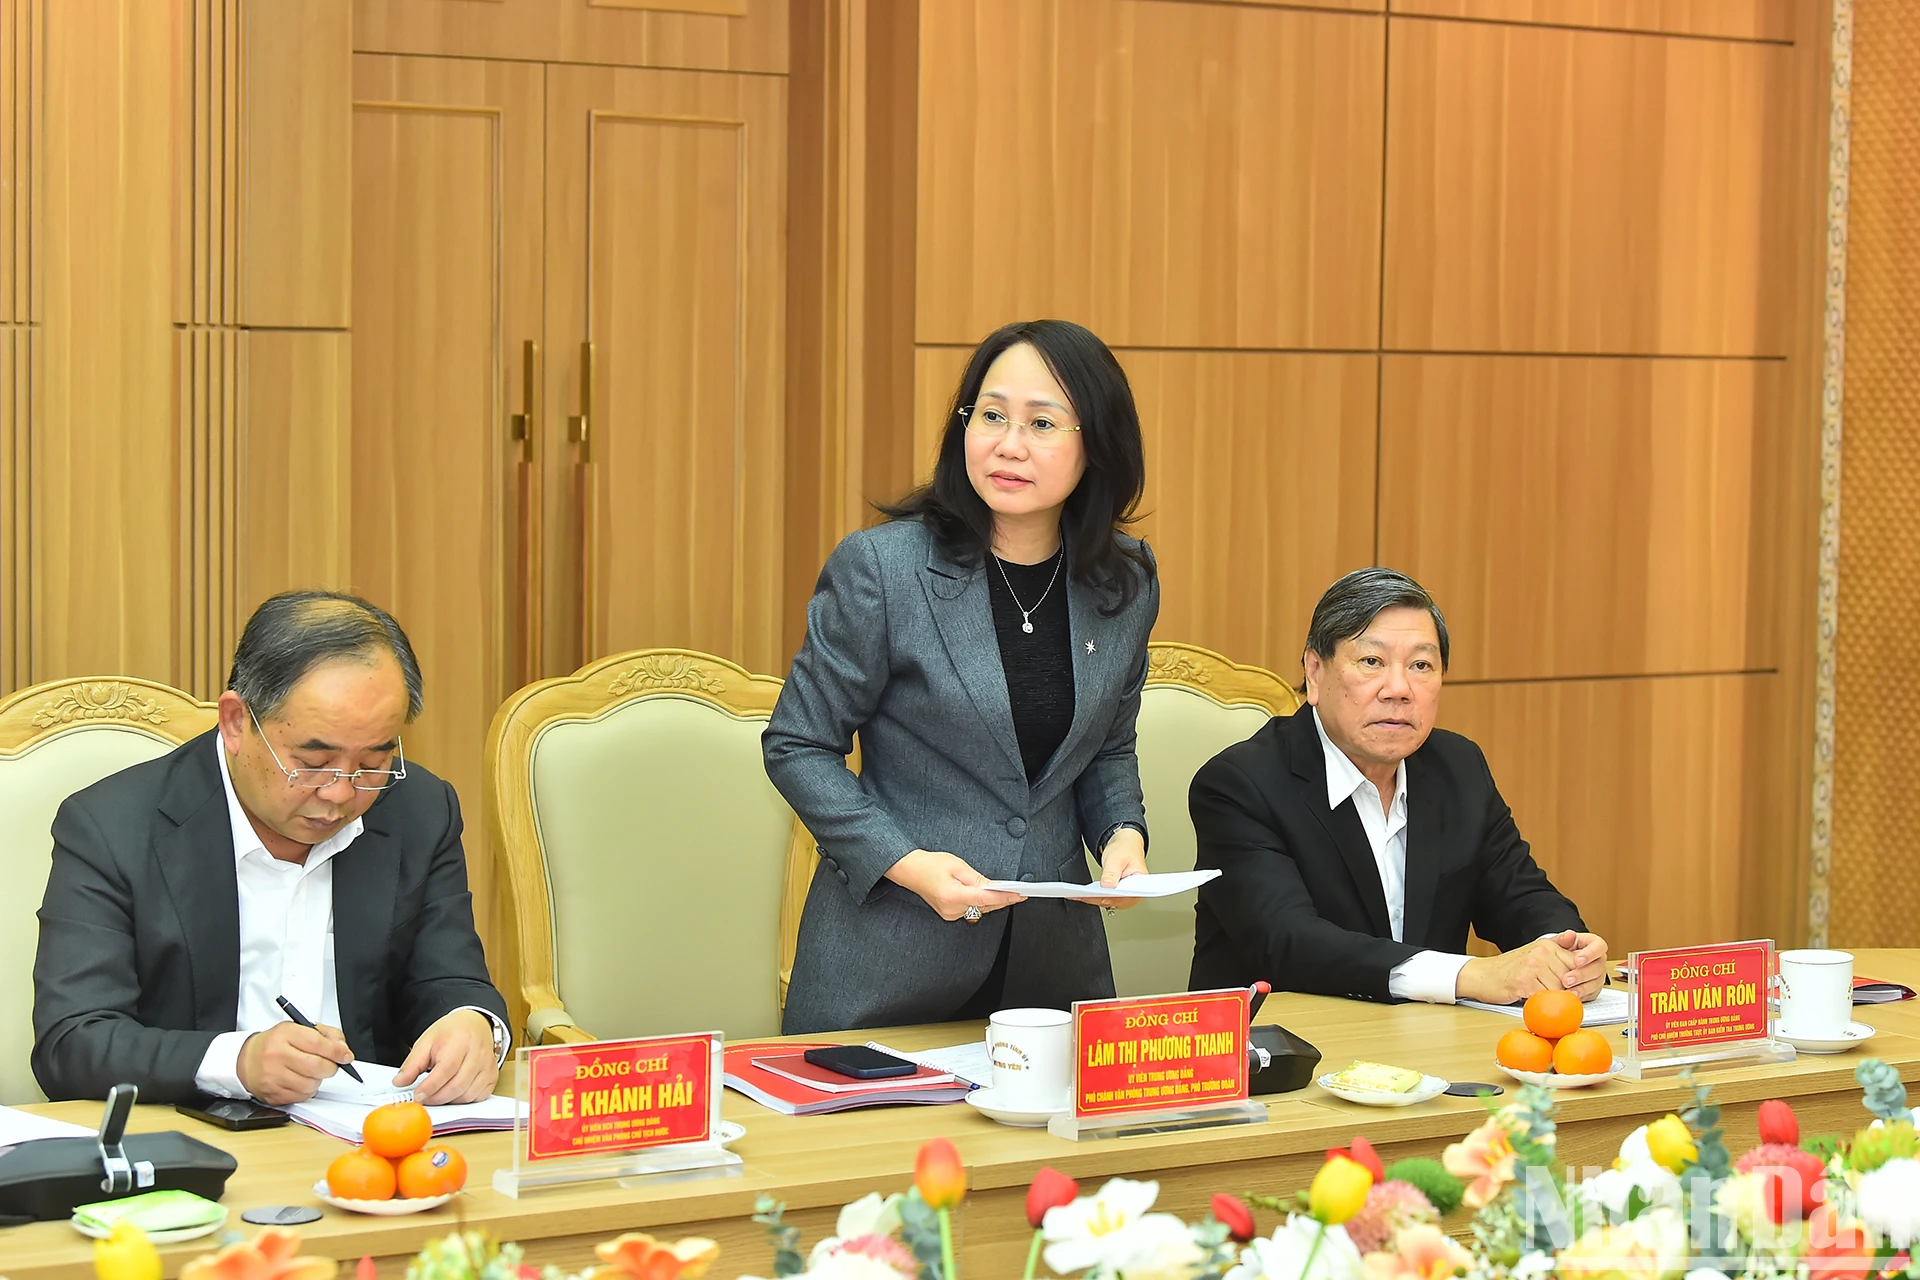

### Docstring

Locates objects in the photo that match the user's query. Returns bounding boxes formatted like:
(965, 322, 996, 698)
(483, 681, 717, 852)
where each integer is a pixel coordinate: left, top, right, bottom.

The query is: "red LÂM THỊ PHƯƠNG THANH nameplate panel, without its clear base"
(1073, 986, 1248, 1119)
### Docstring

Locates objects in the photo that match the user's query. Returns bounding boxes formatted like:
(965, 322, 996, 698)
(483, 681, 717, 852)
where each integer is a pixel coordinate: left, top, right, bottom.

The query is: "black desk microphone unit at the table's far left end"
(0, 1084, 240, 1222)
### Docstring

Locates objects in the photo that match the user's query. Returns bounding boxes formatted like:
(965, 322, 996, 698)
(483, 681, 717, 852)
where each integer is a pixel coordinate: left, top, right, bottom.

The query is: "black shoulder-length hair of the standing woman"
(879, 320, 1154, 616)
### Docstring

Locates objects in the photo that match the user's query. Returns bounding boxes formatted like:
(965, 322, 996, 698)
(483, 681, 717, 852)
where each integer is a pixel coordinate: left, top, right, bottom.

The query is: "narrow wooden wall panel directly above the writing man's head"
(232, 330, 351, 610)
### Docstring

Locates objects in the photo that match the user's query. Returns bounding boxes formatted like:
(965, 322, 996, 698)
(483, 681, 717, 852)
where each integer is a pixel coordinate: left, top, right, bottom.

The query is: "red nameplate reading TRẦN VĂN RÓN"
(1634, 942, 1772, 1054)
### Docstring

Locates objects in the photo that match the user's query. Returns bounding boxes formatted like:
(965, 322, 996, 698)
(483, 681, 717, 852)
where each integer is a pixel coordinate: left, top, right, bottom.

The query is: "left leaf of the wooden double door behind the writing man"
(349, 56, 543, 975)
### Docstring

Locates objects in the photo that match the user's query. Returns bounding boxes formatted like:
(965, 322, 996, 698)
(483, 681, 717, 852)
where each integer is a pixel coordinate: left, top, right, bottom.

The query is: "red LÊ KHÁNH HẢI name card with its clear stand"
(493, 1031, 743, 1199)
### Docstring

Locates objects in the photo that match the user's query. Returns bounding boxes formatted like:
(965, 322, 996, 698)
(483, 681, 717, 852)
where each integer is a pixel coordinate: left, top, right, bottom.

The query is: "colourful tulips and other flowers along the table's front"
(94, 1059, 1920, 1280)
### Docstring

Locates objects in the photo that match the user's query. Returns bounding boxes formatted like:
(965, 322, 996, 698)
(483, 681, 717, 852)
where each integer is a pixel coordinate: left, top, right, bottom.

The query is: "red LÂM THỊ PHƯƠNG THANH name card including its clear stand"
(1046, 986, 1267, 1142)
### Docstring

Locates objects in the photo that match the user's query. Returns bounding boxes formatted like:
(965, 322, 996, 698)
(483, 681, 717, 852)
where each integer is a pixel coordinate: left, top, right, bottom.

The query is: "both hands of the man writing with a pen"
(238, 1009, 499, 1107)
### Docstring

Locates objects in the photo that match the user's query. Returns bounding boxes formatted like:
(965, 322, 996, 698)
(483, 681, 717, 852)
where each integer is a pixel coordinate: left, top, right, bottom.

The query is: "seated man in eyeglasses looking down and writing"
(33, 591, 509, 1105)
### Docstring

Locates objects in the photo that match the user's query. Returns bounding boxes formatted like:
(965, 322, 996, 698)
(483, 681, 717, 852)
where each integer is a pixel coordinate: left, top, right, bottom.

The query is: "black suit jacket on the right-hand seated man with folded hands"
(1187, 706, 1586, 1000)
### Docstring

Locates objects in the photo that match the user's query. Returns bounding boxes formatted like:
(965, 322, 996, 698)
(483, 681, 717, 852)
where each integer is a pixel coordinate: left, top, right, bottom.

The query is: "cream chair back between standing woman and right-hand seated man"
(1106, 641, 1302, 996)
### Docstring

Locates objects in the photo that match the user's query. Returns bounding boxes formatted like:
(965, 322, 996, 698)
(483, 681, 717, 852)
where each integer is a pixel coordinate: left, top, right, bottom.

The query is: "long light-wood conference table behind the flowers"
(0, 950, 1920, 1280)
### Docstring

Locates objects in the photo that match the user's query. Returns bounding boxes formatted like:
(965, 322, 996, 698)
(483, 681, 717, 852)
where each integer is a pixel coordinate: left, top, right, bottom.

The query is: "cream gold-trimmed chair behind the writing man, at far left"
(0, 676, 217, 1105)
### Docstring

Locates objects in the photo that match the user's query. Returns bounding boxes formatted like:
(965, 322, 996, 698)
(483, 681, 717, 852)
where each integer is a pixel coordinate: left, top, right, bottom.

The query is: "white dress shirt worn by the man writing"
(194, 739, 507, 1098)
